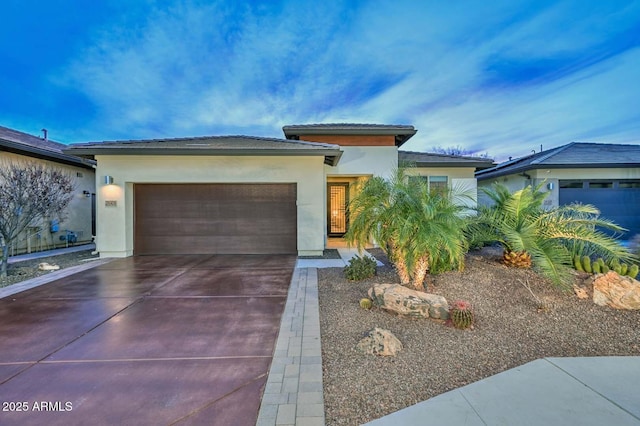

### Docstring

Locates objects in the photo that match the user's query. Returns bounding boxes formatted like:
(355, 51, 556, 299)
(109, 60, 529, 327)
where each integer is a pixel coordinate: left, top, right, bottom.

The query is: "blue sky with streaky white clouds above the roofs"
(0, 0, 640, 160)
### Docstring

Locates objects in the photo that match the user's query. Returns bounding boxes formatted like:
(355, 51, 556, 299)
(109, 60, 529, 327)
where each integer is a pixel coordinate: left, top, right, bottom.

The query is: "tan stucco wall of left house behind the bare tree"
(0, 152, 96, 254)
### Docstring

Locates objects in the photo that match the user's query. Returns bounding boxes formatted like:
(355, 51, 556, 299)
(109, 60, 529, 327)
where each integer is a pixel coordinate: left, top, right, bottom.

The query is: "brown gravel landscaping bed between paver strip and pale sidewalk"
(318, 249, 640, 425)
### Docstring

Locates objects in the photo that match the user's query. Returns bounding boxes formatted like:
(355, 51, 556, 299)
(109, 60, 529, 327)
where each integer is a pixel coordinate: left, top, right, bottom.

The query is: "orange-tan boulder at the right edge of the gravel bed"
(593, 271, 640, 309)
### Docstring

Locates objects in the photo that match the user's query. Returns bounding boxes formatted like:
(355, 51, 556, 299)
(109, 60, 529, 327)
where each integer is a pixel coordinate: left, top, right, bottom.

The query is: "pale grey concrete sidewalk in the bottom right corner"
(367, 357, 640, 426)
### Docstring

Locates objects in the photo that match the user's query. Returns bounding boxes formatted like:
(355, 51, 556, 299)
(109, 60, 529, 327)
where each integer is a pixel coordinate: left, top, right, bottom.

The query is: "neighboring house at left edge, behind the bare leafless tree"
(0, 126, 96, 255)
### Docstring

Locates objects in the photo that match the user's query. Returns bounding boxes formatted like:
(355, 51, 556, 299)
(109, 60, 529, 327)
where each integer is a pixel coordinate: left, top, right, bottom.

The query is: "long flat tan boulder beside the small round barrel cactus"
(369, 284, 449, 320)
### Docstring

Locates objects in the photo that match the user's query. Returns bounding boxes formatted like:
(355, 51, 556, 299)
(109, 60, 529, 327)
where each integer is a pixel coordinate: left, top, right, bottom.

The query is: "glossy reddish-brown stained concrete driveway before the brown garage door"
(0, 256, 296, 425)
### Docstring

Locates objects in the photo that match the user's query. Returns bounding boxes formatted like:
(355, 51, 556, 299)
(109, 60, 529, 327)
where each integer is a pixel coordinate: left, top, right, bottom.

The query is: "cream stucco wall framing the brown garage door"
(96, 155, 326, 257)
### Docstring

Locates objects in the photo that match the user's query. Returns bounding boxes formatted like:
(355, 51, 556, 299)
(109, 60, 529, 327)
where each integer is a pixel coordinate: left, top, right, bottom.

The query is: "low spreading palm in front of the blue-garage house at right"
(469, 182, 633, 286)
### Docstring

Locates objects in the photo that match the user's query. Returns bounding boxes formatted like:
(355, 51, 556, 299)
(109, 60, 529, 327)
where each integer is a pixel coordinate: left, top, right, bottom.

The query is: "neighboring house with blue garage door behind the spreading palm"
(476, 142, 640, 237)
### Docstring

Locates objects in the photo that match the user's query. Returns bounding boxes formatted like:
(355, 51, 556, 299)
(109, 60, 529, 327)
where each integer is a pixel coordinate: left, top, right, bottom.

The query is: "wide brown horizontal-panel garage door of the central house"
(134, 184, 297, 255)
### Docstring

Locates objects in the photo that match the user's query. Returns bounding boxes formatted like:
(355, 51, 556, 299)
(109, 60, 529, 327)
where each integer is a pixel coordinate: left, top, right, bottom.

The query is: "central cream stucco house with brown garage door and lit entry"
(65, 124, 489, 257)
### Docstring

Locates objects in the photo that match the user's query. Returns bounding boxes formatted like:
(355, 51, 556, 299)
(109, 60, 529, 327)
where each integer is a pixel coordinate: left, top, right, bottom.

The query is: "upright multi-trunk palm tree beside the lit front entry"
(345, 169, 467, 290)
